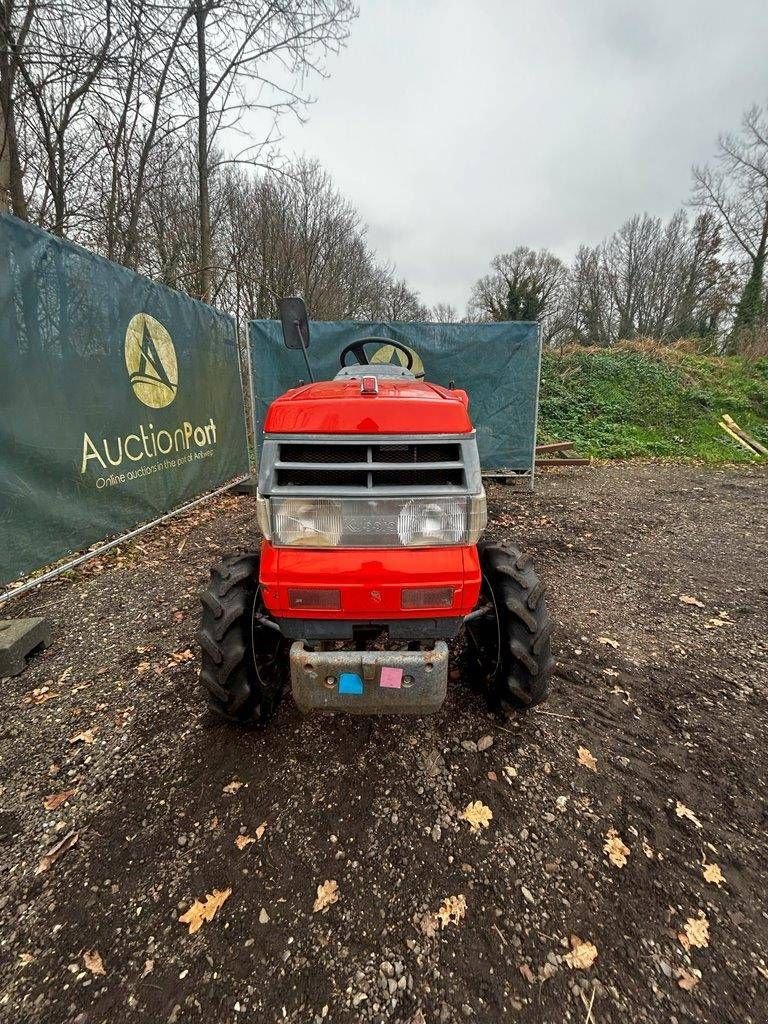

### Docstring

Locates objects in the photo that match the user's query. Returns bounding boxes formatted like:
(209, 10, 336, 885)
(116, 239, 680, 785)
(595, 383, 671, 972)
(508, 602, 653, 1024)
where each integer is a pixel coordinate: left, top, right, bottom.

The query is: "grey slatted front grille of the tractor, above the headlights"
(259, 436, 476, 495)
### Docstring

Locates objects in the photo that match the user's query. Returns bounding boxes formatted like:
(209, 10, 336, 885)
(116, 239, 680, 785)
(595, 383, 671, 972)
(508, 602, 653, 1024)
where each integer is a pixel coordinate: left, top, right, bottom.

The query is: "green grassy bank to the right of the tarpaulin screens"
(539, 347, 768, 463)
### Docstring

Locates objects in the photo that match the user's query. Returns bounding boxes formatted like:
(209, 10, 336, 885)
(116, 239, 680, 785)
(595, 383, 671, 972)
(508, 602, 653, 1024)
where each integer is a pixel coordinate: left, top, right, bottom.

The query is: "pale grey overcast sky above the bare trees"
(283, 0, 768, 313)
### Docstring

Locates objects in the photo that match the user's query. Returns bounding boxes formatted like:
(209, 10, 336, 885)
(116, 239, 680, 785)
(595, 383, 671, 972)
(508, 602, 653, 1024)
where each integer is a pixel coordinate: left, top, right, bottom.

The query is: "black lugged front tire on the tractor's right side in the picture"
(479, 544, 554, 711)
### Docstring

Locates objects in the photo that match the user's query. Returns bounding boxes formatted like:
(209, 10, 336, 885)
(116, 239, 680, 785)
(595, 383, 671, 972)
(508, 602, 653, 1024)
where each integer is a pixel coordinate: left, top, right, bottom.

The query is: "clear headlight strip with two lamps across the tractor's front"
(270, 494, 486, 548)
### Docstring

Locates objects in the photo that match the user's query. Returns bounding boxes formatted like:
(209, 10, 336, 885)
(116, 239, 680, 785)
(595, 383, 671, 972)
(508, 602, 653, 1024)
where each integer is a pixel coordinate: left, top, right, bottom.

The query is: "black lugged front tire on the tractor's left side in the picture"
(198, 554, 287, 725)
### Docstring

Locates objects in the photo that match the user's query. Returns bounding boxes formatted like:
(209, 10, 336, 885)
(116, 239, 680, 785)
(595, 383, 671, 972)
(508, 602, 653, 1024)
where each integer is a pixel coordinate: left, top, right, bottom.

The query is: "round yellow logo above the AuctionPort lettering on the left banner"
(125, 313, 178, 409)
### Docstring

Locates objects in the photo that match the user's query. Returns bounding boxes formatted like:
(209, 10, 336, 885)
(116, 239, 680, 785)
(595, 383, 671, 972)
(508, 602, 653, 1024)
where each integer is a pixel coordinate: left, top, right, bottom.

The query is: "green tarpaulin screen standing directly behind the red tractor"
(250, 321, 541, 474)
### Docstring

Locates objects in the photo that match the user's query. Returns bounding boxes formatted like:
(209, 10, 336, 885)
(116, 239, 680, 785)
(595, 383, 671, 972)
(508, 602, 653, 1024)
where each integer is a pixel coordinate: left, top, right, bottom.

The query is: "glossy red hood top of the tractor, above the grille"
(264, 377, 472, 434)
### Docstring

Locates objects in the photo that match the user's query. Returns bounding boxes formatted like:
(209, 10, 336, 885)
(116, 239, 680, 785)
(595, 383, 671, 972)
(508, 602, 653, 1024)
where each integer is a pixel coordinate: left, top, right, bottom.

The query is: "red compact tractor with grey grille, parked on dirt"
(199, 299, 553, 724)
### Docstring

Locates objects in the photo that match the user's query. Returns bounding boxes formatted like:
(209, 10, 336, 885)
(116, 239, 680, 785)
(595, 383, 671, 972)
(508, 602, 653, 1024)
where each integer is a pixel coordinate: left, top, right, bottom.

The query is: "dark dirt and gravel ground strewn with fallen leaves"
(0, 464, 768, 1024)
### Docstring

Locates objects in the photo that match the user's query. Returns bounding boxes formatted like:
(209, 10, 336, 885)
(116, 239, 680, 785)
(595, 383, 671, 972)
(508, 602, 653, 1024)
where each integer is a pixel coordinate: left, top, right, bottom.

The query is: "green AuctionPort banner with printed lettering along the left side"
(0, 215, 248, 584)
